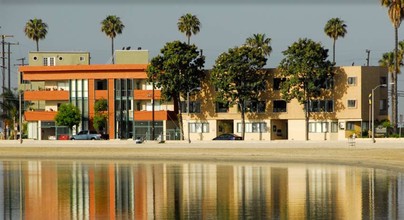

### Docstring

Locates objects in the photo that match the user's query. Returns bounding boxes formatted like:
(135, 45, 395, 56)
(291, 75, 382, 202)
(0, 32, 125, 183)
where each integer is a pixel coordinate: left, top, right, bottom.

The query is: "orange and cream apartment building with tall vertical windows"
(20, 50, 178, 140)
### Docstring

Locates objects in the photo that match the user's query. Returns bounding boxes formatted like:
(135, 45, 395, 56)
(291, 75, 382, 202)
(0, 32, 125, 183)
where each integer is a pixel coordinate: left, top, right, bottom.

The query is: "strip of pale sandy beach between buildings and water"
(0, 139, 404, 172)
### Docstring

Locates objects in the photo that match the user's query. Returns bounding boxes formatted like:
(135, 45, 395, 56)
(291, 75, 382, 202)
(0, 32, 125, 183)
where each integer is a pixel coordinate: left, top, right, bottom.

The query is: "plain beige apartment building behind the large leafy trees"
(183, 66, 388, 141)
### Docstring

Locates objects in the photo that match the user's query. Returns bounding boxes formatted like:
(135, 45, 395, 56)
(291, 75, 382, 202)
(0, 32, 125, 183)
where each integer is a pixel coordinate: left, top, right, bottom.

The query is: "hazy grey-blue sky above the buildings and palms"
(0, 0, 404, 117)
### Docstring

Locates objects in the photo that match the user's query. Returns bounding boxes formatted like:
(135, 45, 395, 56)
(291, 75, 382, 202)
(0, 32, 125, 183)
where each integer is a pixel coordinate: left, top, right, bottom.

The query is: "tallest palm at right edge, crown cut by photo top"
(380, 0, 404, 133)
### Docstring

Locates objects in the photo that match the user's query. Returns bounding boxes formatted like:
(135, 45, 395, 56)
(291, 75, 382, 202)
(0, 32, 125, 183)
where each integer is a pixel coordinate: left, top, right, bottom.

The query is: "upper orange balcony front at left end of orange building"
(24, 90, 69, 101)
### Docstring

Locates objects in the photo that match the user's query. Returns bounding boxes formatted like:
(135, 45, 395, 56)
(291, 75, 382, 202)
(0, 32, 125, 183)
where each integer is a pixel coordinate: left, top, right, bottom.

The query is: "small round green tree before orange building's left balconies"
(55, 103, 81, 131)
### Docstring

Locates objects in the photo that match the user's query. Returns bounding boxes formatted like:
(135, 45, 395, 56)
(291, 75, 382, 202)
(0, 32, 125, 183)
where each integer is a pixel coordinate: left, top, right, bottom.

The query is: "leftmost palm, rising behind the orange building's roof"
(24, 18, 48, 51)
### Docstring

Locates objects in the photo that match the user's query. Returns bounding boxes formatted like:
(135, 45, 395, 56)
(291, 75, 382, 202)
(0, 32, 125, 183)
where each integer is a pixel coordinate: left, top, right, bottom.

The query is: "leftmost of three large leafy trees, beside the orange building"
(147, 41, 205, 138)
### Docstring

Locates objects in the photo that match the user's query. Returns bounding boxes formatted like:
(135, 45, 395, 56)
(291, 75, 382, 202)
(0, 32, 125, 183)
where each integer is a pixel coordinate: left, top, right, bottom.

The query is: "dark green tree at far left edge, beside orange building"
(0, 88, 24, 139)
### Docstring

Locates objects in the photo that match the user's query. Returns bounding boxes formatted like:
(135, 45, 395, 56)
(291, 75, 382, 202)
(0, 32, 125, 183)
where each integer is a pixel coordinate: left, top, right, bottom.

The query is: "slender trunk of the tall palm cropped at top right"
(391, 27, 399, 134)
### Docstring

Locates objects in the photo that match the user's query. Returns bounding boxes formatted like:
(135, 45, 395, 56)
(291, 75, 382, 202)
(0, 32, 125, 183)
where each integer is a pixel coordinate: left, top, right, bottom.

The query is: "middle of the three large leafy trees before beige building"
(211, 46, 267, 140)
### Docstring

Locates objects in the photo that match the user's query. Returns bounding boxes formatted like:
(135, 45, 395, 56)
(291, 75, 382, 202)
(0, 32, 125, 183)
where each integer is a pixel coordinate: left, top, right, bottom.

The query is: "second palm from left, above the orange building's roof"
(101, 15, 125, 63)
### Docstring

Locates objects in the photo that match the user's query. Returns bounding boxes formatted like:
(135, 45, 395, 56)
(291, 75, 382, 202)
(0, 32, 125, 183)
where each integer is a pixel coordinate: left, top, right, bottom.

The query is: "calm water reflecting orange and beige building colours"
(0, 161, 404, 219)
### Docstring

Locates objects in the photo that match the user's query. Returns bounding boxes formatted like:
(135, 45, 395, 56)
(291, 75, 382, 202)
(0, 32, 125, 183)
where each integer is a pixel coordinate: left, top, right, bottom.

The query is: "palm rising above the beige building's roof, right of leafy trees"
(324, 18, 347, 63)
